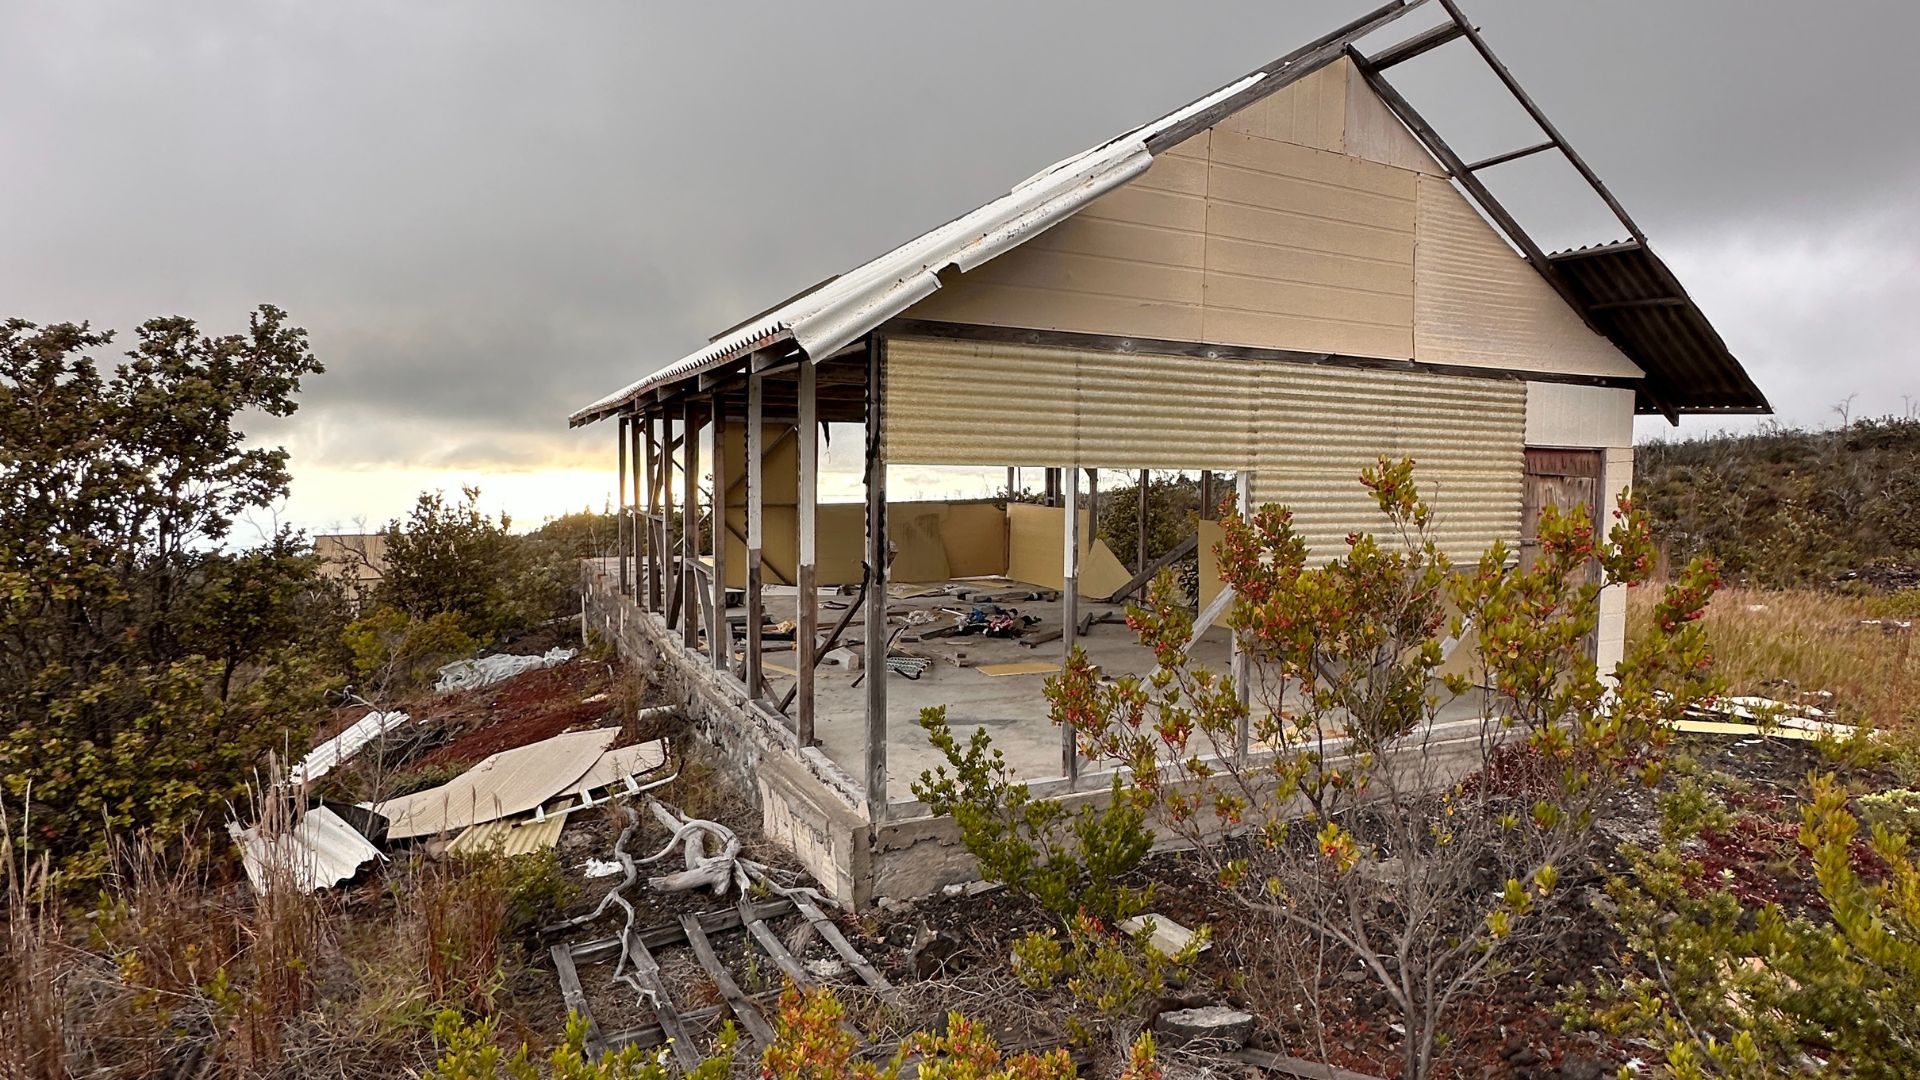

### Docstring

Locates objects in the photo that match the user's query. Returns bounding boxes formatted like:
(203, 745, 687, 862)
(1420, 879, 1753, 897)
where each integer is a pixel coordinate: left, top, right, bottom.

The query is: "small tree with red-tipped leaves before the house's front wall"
(1048, 459, 1715, 1078)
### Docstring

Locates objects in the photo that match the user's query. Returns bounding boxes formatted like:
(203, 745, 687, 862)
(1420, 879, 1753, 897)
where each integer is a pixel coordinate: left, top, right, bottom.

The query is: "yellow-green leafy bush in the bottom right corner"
(1569, 774, 1920, 1080)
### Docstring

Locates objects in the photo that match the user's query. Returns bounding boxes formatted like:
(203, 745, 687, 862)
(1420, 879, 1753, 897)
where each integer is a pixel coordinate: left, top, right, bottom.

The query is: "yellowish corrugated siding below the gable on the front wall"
(887, 338, 1526, 557)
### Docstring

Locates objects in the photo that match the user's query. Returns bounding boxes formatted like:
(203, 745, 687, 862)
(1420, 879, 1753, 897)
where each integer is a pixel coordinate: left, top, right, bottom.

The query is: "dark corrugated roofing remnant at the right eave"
(1549, 240, 1772, 413)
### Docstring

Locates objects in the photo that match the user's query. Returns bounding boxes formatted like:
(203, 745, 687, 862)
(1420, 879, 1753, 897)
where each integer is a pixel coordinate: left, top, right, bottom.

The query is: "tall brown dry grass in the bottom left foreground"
(0, 791, 564, 1080)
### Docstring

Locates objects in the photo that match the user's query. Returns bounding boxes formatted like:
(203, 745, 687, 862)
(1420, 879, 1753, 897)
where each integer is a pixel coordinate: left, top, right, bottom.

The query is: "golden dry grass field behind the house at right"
(1626, 588, 1920, 734)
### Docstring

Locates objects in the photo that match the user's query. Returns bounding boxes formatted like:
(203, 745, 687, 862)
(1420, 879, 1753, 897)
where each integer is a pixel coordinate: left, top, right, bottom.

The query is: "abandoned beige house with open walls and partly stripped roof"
(572, 0, 1768, 903)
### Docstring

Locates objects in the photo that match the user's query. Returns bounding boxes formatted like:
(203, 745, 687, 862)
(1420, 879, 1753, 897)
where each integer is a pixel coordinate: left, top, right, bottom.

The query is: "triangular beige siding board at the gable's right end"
(1413, 177, 1642, 377)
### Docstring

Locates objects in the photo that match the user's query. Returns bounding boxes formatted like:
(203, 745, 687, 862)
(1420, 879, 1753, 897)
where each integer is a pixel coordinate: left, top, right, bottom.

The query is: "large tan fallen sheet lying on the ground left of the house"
(372, 728, 620, 840)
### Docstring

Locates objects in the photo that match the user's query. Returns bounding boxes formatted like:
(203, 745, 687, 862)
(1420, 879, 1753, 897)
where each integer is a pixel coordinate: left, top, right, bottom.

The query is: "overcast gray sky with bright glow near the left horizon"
(0, 0, 1920, 525)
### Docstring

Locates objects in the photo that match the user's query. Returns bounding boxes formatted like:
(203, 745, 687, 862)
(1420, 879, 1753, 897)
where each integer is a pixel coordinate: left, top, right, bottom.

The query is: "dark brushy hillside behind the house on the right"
(1634, 417, 1920, 590)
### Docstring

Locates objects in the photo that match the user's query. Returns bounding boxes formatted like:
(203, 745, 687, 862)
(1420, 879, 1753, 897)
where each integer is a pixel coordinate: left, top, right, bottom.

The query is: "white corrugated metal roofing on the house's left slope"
(568, 0, 1425, 427)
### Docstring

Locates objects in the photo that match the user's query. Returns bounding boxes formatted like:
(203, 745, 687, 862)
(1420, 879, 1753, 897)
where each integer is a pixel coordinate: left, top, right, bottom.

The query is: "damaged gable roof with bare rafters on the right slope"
(568, 0, 1770, 427)
